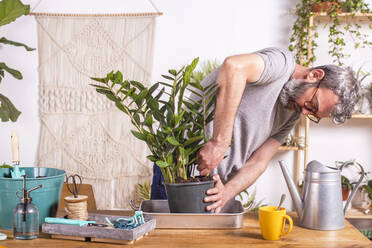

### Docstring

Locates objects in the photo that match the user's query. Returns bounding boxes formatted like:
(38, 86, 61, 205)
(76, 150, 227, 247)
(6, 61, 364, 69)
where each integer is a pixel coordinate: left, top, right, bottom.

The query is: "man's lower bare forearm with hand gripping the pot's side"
(204, 138, 280, 213)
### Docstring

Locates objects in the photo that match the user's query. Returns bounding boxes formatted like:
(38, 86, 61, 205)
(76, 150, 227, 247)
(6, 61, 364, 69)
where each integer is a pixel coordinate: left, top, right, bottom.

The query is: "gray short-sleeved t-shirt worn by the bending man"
(202, 48, 299, 182)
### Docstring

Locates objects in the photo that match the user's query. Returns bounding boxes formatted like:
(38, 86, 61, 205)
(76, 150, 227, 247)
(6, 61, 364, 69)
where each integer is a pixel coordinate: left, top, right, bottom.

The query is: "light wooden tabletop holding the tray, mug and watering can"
(0, 211, 372, 248)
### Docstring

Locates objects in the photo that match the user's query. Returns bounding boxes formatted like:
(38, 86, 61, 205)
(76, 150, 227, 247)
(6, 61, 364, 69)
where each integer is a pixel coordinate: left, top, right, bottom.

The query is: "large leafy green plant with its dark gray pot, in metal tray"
(92, 58, 216, 212)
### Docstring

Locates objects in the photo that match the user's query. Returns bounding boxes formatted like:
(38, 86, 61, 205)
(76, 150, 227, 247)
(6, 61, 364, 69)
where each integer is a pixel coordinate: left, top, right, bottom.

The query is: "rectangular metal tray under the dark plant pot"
(140, 200, 244, 229)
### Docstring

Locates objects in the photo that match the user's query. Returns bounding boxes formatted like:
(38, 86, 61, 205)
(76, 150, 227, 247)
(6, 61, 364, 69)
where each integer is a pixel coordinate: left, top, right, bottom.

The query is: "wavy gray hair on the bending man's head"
(311, 65, 360, 124)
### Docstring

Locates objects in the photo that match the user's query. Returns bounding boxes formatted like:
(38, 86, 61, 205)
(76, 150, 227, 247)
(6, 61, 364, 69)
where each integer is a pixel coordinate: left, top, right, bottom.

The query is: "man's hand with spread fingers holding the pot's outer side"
(204, 175, 232, 213)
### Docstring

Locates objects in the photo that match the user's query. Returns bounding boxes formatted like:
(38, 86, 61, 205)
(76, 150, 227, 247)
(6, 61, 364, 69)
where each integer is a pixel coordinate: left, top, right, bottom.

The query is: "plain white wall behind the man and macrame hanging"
(0, 0, 372, 210)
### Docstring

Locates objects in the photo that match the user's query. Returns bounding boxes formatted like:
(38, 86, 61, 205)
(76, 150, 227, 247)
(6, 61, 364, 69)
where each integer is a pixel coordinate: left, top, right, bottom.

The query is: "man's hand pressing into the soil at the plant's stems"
(197, 140, 227, 176)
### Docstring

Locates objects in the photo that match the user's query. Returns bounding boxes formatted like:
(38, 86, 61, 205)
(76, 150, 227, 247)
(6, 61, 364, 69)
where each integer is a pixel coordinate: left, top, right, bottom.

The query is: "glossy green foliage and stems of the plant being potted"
(91, 59, 215, 183)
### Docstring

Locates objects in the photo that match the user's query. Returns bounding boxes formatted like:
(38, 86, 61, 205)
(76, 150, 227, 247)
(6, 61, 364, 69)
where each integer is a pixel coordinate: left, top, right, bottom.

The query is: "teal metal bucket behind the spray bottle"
(0, 167, 66, 230)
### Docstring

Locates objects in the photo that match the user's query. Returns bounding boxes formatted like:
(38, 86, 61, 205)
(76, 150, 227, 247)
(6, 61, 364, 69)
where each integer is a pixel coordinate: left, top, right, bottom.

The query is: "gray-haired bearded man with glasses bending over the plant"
(197, 48, 359, 213)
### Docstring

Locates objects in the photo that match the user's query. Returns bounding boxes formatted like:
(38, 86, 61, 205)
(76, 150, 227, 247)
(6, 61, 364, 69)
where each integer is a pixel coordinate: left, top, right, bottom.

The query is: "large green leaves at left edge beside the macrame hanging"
(0, 0, 35, 122)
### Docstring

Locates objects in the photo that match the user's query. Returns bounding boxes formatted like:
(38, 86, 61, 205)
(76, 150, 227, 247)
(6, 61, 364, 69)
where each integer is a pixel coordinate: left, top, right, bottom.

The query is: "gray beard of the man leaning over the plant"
(278, 79, 307, 110)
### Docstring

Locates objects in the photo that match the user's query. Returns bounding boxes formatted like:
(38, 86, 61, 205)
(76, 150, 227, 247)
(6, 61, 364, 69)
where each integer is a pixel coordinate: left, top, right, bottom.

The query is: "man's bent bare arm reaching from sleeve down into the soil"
(198, 54, 264, 175)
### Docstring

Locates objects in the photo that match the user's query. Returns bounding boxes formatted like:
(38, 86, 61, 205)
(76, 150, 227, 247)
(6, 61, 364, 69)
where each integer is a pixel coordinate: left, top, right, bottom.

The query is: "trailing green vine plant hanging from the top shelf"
(289, 0, 372, 66)
